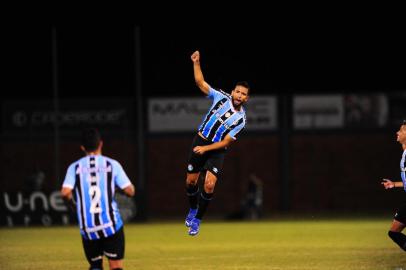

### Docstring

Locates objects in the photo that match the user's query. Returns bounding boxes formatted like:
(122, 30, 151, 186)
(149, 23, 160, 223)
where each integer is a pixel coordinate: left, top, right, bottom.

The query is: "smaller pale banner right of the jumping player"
(293, 95, 344, 129)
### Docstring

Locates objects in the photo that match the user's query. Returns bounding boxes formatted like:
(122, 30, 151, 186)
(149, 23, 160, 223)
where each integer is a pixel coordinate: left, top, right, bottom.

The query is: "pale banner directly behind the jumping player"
(148, 96, 277, 132)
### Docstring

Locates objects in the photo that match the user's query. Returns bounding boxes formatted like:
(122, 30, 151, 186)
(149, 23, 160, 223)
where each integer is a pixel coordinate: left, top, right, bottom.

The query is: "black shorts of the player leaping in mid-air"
(187, 134, 226, 178)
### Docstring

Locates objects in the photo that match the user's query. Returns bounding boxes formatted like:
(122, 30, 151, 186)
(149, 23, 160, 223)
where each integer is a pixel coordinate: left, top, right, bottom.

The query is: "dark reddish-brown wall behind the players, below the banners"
(0, 133, 406, 217)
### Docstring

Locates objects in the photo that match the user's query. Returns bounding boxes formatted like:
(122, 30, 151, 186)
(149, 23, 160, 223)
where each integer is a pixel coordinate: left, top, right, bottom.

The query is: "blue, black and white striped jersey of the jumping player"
(199, 87, 246, 142)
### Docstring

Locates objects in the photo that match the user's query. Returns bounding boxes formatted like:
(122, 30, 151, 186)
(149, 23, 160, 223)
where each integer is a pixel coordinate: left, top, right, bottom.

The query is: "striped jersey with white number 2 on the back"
(63, 155, 131, 240)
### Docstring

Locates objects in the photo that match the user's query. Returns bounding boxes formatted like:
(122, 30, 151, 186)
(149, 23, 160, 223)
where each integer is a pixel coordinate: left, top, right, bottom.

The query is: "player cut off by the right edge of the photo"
(382, 120, 406, 251)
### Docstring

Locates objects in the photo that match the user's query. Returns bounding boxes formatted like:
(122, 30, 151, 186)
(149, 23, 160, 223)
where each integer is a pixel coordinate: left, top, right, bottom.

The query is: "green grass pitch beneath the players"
(0, 219, 406, 270)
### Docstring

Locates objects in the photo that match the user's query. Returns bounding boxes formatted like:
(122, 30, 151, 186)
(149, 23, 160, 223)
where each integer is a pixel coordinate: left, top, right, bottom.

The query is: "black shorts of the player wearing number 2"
(82, 227, 124, 264)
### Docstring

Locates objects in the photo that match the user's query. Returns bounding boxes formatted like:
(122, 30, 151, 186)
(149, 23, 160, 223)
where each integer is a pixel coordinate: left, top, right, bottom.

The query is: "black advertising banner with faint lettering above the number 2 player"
(2, 99, 133, 134)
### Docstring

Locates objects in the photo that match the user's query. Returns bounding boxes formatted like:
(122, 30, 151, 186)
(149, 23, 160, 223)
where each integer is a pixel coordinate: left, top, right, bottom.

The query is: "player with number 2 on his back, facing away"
(61, 128, 135, 270)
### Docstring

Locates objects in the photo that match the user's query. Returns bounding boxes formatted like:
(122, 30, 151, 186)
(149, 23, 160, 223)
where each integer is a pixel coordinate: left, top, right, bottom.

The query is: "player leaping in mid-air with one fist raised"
(185, 51, 250, 236)
